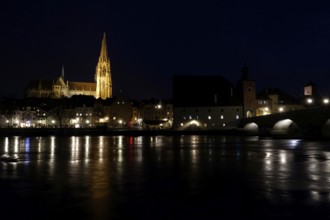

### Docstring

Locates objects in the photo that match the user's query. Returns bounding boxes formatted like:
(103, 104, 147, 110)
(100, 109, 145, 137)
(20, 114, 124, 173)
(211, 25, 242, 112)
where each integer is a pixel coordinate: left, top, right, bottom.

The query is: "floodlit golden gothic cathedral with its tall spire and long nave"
(25, 33, 112, 99)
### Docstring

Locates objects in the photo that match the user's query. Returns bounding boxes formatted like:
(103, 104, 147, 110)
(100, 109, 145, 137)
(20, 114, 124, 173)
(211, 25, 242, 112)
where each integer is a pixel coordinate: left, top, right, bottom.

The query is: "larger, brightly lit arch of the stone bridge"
(272, 118, 301, 135)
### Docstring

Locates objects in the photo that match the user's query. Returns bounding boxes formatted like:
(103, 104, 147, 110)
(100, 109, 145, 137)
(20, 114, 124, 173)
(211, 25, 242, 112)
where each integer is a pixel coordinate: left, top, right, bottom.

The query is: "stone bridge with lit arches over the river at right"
(240, 107, 330, 138)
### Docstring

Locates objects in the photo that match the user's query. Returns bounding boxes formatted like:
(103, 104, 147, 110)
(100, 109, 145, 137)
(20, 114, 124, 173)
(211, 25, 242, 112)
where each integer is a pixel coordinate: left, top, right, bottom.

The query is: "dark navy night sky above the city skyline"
(0, 0, 330, 99)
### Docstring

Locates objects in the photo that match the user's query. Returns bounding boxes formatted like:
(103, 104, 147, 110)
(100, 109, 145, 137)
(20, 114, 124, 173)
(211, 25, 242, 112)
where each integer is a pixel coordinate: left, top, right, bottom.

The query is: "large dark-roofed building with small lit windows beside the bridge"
(173, 75, 243, 130)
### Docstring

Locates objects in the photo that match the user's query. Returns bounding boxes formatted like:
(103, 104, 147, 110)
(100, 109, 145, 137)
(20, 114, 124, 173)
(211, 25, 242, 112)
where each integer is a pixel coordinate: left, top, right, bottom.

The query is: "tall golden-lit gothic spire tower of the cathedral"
(95, 33, 112, 99)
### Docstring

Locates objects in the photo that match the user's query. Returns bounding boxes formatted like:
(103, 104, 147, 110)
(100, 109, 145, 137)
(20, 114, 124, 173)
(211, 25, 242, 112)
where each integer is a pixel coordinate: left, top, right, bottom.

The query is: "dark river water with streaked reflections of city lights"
(0, 135, 330, 220)
